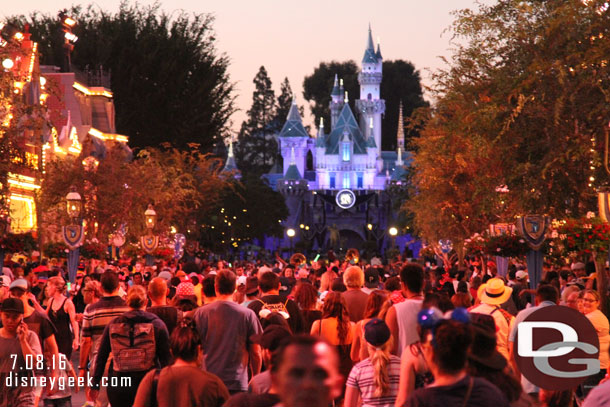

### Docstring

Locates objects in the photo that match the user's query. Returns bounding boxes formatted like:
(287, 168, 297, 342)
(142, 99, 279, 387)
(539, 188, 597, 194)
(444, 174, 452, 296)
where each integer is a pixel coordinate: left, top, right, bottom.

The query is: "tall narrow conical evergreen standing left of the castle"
(235, 66, 277, 175)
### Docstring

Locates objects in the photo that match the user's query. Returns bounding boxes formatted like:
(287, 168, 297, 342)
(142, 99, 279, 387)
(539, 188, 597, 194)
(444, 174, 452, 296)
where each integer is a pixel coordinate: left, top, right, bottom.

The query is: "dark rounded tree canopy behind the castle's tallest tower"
(303, 59, 428, 150)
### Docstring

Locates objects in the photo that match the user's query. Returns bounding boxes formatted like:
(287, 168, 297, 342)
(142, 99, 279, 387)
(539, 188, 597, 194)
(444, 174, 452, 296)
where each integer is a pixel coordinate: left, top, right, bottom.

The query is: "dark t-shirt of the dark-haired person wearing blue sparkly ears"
(404, 375, 509, 407)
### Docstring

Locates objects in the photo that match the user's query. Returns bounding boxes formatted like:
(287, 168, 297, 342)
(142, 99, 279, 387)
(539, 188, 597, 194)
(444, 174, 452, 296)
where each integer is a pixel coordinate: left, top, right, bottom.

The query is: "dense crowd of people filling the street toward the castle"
(0, 250, 610, 407)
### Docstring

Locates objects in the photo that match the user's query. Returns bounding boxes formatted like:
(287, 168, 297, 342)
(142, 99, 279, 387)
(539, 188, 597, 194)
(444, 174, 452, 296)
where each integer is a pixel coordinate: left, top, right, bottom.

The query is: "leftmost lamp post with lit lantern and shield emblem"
(62, 185, 85, 283)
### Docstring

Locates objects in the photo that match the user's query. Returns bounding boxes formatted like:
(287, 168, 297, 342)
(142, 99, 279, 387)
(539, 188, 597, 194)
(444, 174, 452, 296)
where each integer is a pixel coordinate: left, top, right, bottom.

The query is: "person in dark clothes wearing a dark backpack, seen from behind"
(90, 285, 171, 407)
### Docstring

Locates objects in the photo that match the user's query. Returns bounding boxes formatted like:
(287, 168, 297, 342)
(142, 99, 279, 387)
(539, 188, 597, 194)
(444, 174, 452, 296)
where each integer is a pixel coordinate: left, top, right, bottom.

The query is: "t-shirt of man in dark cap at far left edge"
(0, 331, 42, 407)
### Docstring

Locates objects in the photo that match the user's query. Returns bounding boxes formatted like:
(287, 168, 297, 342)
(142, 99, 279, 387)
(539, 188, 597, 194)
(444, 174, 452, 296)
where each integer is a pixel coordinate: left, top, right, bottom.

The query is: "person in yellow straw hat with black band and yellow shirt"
(470, 277, 515, 360)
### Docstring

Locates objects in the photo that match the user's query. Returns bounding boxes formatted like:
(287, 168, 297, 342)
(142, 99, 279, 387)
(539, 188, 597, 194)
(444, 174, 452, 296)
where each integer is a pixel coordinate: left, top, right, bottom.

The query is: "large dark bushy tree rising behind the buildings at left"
(20, 1, 234, 152)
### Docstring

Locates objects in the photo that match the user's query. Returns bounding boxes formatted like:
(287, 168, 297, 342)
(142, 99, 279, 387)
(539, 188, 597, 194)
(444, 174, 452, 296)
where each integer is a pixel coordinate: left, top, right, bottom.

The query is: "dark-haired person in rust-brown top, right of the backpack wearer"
(133, 320, 229, 407)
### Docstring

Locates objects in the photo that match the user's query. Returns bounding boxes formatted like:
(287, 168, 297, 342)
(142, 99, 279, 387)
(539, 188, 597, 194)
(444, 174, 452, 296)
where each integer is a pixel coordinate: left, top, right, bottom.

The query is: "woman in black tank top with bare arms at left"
(46, 276, 80, 360)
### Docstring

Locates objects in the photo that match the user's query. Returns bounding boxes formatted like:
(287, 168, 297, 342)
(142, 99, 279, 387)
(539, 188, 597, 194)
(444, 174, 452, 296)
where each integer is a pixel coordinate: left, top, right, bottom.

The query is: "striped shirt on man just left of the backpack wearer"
(81, 296, 129, 360)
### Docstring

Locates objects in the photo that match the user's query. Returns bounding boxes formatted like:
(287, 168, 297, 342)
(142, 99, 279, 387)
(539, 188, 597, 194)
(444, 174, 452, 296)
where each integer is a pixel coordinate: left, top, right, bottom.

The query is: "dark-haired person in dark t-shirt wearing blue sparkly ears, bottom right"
(404, 319, 509, 407)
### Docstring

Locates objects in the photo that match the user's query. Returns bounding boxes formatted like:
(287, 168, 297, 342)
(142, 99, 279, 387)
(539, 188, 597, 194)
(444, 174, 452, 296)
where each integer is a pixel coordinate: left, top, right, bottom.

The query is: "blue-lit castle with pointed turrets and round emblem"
(245, 27, 409, 250)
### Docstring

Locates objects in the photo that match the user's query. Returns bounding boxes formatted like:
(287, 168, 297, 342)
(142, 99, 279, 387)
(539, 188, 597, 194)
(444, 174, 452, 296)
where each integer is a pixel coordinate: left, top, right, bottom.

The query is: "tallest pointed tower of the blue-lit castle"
(356, 25, 385, 156)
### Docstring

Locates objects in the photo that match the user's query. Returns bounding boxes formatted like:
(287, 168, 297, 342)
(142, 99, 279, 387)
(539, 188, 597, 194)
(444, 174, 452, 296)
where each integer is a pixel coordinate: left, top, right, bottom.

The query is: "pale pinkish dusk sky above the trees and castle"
(0, 0, 493, 129)
